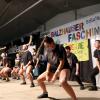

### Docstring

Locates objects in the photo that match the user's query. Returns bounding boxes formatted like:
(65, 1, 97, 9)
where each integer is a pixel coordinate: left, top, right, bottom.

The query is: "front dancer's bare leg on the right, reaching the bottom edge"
(59, 69, 77, 100)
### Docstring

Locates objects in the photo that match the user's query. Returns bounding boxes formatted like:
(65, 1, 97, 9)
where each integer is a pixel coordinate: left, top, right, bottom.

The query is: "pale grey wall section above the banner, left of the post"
(46, 11, 75, 30)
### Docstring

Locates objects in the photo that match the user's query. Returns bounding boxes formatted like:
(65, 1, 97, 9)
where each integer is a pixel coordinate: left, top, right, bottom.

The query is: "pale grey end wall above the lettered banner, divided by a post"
(42, 4, 100, 31)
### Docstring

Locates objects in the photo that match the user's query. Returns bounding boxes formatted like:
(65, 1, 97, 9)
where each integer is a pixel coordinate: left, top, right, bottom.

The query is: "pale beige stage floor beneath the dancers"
(0, 79, 100, 100)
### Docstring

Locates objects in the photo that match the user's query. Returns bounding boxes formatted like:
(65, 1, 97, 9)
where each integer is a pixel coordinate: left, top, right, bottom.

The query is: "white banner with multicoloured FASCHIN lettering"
(49, 13, 100, 44)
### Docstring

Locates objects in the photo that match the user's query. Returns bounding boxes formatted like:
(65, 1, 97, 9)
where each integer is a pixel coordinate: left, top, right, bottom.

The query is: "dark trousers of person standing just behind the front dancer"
(70, 67, 83, 86)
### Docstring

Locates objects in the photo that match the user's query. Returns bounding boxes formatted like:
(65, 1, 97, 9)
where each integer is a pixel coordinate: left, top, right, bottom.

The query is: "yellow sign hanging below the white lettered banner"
(64, 40, 89, 61)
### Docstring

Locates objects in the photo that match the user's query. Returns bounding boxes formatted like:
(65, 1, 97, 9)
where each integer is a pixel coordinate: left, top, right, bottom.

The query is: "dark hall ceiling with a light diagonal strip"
(0, 0, 100, 45)
